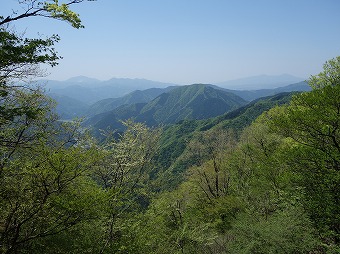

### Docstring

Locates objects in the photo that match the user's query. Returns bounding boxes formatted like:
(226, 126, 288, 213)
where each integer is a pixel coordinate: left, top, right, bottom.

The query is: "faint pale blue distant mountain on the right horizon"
(214, 74, 305, 90)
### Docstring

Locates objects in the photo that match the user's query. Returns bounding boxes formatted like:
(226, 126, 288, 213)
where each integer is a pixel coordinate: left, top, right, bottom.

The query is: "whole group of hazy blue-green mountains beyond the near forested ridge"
(46, 74, 310, 128)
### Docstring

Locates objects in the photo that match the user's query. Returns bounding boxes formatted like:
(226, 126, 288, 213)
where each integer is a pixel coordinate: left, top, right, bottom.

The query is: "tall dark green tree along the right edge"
(269, 57, 340, 252)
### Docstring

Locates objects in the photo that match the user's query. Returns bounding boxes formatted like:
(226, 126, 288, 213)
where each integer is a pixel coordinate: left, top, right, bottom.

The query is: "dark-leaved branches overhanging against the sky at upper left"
(0, 0, 94, 145)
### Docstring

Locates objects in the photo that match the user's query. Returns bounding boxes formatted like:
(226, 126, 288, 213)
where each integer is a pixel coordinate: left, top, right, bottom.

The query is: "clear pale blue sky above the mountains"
(0, 0, 340, 84)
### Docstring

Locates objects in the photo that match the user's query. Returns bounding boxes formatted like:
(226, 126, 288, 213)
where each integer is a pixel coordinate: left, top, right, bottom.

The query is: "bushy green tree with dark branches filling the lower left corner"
(0, 120, 100, 253)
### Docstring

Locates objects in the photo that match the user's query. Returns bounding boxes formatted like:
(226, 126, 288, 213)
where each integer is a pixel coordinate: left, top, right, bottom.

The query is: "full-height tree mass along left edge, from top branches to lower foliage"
(0, 0, 100, 253)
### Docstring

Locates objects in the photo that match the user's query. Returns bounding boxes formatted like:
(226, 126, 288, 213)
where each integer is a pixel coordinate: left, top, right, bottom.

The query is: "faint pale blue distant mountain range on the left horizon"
(40, 76, 175, 104)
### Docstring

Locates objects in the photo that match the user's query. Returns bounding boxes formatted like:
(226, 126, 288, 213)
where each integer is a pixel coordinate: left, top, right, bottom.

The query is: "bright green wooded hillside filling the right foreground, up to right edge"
(134, 60, 340, 253)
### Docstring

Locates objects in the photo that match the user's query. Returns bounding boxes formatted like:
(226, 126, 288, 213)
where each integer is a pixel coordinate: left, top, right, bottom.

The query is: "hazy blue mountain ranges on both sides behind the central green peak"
(40, 75, 310, 119)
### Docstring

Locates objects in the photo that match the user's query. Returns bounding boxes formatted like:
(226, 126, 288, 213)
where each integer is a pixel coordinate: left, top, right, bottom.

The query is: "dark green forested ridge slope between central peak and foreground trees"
(153, 92, 296, 190)
